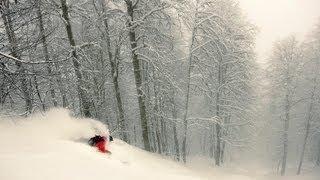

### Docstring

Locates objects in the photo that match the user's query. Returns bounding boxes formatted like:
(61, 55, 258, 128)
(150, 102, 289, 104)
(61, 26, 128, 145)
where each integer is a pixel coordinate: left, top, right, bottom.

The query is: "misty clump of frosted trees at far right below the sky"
(267, 20, 320, 175)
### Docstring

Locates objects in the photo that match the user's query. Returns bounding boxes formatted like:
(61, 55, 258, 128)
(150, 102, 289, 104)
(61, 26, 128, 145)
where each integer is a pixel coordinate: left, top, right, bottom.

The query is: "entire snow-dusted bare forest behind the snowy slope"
(0, 0, 320, 175)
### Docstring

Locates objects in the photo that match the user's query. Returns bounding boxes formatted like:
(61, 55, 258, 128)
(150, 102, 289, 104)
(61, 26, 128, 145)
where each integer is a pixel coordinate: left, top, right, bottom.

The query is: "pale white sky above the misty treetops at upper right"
(239, 0, 320, 62)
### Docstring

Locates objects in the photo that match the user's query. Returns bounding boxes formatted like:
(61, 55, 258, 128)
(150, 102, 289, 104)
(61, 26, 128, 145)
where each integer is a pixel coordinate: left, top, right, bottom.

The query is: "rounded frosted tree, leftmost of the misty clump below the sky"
(269, 37, 301, 175)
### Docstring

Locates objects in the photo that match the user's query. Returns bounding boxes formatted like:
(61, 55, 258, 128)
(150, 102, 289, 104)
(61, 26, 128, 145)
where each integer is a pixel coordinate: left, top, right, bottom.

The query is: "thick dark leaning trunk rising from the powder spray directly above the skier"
(60, 0, 92, 117)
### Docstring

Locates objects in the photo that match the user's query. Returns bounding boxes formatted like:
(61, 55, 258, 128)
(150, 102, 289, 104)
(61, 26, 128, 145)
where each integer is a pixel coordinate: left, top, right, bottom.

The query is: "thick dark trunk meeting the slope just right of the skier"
(125, 0, 150, 151)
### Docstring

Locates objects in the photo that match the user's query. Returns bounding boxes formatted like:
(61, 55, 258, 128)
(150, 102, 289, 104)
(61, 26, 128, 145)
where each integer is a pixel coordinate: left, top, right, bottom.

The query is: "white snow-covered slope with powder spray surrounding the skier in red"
(0, 109, 320, 180)
